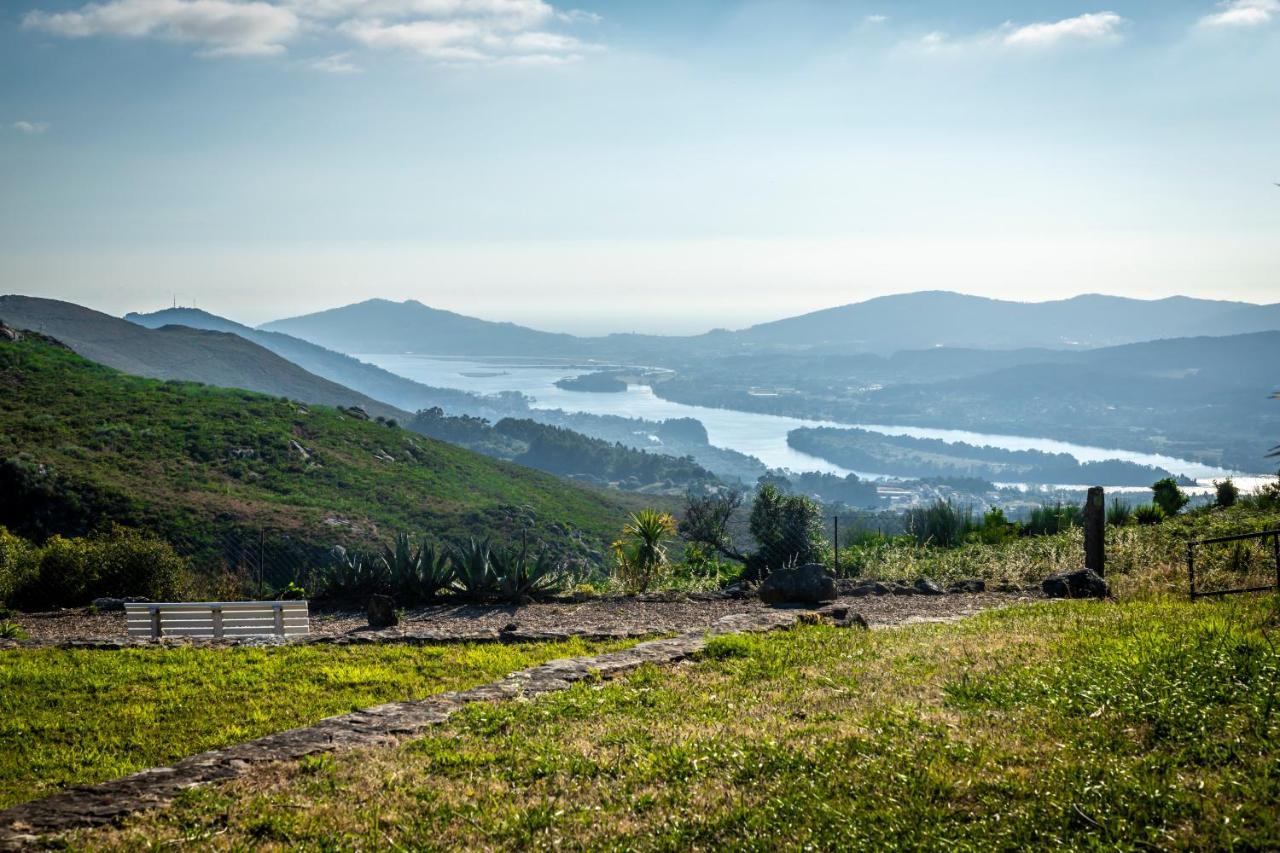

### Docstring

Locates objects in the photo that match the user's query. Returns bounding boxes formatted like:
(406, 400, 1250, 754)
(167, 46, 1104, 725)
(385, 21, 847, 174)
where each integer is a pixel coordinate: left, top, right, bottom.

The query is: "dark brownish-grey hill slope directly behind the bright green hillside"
(0, 296, 408, 419)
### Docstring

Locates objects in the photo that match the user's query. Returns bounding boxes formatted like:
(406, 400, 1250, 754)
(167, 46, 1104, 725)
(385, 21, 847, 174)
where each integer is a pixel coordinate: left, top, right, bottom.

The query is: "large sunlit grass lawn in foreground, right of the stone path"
(80, 597, 1280, 850)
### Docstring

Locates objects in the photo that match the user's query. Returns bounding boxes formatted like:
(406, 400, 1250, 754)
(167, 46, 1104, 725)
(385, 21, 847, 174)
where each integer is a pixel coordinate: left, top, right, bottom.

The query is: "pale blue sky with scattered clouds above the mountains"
(0, 0, 1280, 333)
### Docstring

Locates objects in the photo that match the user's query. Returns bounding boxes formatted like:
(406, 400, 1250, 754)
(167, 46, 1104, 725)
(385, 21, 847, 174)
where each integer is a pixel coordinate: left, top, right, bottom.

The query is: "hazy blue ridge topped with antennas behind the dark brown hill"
(127, 307, 524, 416)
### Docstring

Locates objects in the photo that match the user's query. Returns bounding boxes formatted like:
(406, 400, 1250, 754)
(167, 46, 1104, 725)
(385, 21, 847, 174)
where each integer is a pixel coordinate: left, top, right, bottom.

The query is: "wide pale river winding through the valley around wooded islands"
(356, 353, 1263, 491)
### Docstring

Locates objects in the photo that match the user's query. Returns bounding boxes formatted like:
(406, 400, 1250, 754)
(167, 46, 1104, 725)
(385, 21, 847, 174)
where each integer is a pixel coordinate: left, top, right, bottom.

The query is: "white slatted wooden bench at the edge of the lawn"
(124, 601, 311, 639)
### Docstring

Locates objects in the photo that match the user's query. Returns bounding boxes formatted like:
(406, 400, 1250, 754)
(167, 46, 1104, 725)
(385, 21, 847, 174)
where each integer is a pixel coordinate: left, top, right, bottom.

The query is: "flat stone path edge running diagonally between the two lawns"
(0, 608, 824, 850)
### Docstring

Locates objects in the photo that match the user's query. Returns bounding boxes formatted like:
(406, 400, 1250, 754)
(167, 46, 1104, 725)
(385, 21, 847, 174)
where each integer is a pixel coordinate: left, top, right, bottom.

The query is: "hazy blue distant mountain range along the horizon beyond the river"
(261, 291, 1280, 359)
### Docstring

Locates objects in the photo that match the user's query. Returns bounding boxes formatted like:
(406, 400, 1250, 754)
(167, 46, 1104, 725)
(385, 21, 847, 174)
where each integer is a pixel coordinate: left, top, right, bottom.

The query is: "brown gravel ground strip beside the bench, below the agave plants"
(10, 592, 1038, 643)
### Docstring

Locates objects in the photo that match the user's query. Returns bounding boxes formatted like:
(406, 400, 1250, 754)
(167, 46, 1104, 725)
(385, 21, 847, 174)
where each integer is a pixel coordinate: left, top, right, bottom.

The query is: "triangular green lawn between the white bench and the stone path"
(0, 642, 626, 808)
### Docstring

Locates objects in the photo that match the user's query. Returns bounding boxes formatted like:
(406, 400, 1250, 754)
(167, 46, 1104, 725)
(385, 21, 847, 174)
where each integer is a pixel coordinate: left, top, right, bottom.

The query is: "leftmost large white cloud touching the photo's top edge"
(22, 0, 298, 56)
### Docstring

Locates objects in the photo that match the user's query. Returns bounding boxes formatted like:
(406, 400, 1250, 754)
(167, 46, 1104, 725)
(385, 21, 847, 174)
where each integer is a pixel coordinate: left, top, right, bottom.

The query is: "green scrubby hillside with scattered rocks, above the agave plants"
(0, 334, 634, 556)
